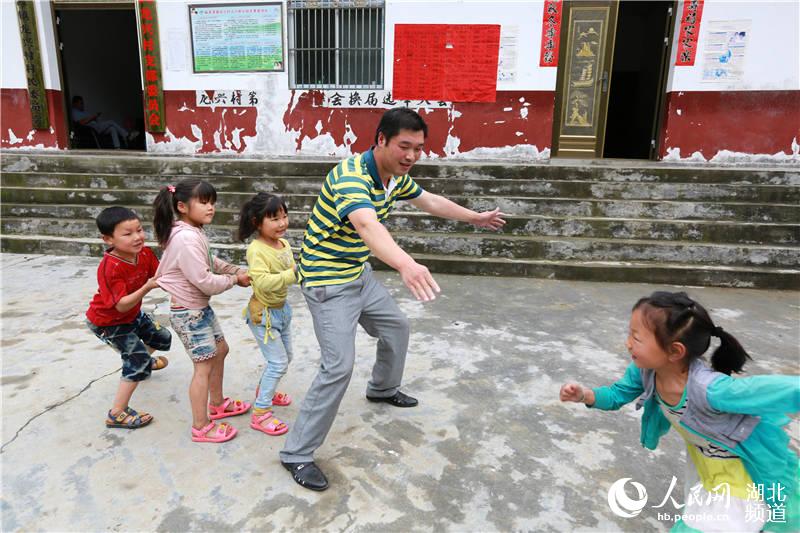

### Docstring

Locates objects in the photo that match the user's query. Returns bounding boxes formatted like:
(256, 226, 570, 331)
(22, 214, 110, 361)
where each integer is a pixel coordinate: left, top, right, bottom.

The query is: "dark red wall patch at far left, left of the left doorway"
(0, 88, 67, 149)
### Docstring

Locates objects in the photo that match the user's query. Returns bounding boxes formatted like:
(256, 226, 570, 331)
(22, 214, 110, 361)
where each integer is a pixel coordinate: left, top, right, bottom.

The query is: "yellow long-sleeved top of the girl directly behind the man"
(247, 239, 297, 324)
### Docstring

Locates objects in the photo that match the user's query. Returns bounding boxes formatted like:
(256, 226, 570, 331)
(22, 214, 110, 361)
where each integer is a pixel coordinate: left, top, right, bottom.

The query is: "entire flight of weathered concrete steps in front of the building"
(0, 152, 800, 290)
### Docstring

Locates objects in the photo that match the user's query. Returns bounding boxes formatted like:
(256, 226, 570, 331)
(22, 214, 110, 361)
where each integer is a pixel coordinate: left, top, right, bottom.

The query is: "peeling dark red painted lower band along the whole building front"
(0, 88, 800, 159)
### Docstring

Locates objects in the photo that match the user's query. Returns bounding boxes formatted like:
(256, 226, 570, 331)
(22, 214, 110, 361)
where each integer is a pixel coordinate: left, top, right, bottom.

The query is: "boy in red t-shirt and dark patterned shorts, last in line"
(86, 206, 172, 429)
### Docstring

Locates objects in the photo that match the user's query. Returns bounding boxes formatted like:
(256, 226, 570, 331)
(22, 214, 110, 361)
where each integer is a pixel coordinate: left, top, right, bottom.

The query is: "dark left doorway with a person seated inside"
(55, 4, 145, 150)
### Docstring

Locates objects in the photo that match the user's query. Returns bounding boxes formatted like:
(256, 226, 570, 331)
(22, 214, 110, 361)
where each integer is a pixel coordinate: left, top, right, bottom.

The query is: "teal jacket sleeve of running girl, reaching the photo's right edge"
(706, 375, 800, 415)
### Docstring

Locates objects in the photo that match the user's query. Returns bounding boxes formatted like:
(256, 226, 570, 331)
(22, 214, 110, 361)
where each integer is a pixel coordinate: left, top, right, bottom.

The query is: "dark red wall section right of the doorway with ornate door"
(661, 91, 800, 159)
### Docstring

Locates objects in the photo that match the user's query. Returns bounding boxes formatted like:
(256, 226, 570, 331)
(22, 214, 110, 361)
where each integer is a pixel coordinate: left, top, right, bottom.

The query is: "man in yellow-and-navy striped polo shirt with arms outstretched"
(280, 108, 505, 490)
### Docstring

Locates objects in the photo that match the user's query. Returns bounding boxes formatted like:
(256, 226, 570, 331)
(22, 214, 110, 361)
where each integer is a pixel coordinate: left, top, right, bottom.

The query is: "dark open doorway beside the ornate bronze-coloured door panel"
(603, 0, 674, 159)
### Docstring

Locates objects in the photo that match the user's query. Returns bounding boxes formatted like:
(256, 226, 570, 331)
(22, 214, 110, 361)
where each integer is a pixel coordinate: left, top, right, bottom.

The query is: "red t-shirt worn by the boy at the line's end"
(86, 246, 158, 326)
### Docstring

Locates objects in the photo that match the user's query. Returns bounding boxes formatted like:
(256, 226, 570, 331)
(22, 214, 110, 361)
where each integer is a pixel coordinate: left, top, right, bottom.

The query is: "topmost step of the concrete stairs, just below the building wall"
(1, 151, 800, 186)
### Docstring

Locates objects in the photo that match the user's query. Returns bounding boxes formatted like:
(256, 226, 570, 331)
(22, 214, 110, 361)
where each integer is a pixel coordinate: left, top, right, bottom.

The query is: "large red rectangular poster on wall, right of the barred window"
(392, 24, 500, 102)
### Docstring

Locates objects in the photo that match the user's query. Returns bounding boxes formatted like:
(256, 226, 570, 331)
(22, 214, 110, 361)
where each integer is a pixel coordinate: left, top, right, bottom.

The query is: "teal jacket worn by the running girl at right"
(591, 363, 800, 530)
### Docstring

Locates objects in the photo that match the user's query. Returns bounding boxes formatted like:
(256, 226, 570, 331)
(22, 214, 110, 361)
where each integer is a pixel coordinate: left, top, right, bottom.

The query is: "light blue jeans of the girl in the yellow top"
(245, 302, 292, 409)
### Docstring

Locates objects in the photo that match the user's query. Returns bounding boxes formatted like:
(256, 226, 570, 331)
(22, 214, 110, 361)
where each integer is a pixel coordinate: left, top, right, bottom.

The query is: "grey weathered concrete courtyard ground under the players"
(0, 254, 800, 532)
